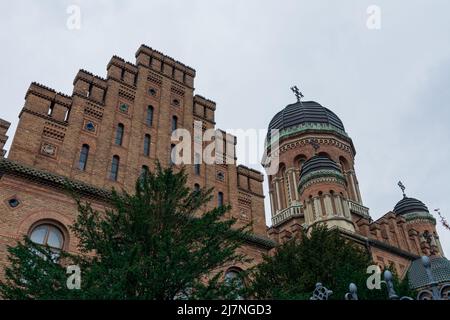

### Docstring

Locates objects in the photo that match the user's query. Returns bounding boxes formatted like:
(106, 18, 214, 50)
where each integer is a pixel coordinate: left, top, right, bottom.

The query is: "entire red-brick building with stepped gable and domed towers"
(0, 45, 443, 290)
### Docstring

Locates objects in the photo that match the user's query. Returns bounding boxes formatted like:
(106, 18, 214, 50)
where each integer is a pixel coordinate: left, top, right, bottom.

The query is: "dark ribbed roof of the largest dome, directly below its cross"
(269, 101, 345, 131)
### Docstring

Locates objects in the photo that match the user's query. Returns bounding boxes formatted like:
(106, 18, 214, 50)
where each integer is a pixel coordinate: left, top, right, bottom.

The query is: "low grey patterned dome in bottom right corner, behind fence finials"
(408, 257, 450, 289)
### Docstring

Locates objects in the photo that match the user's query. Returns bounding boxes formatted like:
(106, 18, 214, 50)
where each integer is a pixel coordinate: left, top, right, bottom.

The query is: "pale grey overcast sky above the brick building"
(0, 0, 450, 256)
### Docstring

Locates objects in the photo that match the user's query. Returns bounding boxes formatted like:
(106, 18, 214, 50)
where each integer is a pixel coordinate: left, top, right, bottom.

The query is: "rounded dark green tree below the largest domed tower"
(248, 227, 407, 300)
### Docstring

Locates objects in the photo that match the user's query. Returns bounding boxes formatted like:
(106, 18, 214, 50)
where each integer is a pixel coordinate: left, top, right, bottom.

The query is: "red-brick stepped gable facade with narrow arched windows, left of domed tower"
(0, 45, 275, 276)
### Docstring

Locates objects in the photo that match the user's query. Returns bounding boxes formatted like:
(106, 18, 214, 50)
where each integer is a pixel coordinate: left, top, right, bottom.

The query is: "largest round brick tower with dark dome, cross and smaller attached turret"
(263, 87, 368, 231)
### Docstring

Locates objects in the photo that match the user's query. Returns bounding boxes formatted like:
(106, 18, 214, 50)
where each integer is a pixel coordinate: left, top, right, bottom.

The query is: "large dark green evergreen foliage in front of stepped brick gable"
(0, 164, 246, 300)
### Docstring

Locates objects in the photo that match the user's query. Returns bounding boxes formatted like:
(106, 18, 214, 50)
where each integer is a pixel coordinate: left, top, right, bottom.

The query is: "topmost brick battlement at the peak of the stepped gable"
(135, 44, 195, 88)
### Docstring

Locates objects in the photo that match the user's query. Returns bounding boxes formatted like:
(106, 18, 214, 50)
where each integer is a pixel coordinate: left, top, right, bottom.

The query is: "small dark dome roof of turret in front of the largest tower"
(300, 155, 343, 184)
